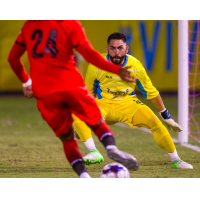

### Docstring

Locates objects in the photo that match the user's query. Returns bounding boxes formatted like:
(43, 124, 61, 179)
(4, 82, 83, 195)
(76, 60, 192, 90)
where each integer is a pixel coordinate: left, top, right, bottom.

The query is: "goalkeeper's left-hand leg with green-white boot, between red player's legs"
(72, 114, 104, 165)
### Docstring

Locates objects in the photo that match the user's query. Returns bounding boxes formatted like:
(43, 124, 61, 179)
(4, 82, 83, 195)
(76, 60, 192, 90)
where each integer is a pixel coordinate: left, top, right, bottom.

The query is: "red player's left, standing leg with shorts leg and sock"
(37, 93, 90, 178)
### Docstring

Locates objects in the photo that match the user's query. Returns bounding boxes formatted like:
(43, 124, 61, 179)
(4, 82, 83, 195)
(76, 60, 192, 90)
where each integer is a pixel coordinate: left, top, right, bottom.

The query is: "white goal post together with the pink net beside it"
(178, 20, 200, 143)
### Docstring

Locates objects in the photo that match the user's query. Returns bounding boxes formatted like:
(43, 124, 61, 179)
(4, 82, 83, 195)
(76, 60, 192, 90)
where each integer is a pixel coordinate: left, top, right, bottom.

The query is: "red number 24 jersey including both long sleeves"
(12, 20, 121, 98)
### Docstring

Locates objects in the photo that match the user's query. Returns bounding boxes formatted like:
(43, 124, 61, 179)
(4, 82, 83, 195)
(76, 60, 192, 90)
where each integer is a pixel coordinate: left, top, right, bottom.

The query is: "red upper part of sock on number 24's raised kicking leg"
(94, 122, 114, 141)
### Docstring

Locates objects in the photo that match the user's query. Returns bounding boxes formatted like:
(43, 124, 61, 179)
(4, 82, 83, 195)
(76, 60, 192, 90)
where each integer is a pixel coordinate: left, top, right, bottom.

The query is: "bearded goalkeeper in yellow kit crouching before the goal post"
(73, 33, 193, 169)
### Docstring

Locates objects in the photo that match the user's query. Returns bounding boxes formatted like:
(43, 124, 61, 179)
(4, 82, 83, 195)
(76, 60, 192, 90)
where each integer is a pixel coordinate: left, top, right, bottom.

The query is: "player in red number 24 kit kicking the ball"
(8, 20, 138, 178)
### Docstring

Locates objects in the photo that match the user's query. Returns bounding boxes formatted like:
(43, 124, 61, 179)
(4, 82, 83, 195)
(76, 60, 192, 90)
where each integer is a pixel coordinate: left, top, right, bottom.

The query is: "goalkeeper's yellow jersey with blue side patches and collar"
(85, 53, 159, 103)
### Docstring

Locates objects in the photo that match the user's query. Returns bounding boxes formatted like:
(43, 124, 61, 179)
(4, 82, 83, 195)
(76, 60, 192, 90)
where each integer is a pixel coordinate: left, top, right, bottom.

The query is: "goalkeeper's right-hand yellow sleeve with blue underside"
(134, 61, 159, 99)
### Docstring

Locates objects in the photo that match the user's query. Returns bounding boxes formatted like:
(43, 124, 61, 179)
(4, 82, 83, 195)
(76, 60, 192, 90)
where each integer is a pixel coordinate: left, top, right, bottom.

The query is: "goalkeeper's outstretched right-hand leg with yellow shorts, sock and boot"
(111, 97, 191, 168)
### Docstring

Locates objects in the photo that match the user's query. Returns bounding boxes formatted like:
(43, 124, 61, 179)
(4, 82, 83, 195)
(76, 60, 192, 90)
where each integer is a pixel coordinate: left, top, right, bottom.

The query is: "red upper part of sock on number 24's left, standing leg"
(63, 140, 83, 165)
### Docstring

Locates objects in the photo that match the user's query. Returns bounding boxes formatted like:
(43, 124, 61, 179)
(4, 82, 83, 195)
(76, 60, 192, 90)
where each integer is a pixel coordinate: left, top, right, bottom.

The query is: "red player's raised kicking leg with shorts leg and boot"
(69, 87, 138, 170)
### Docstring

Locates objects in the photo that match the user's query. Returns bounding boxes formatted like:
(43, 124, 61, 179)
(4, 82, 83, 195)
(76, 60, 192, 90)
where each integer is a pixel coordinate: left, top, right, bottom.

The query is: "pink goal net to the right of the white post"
(188, 20, 200, 142)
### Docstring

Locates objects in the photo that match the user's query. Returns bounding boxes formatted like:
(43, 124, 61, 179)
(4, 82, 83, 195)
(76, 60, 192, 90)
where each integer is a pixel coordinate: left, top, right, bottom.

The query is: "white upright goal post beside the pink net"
(178, 20, 189, 143)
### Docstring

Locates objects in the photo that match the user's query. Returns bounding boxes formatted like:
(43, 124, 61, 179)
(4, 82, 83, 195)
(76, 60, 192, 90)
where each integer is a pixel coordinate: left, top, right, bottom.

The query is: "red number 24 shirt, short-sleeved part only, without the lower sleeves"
(16, 21, 89, 97)
